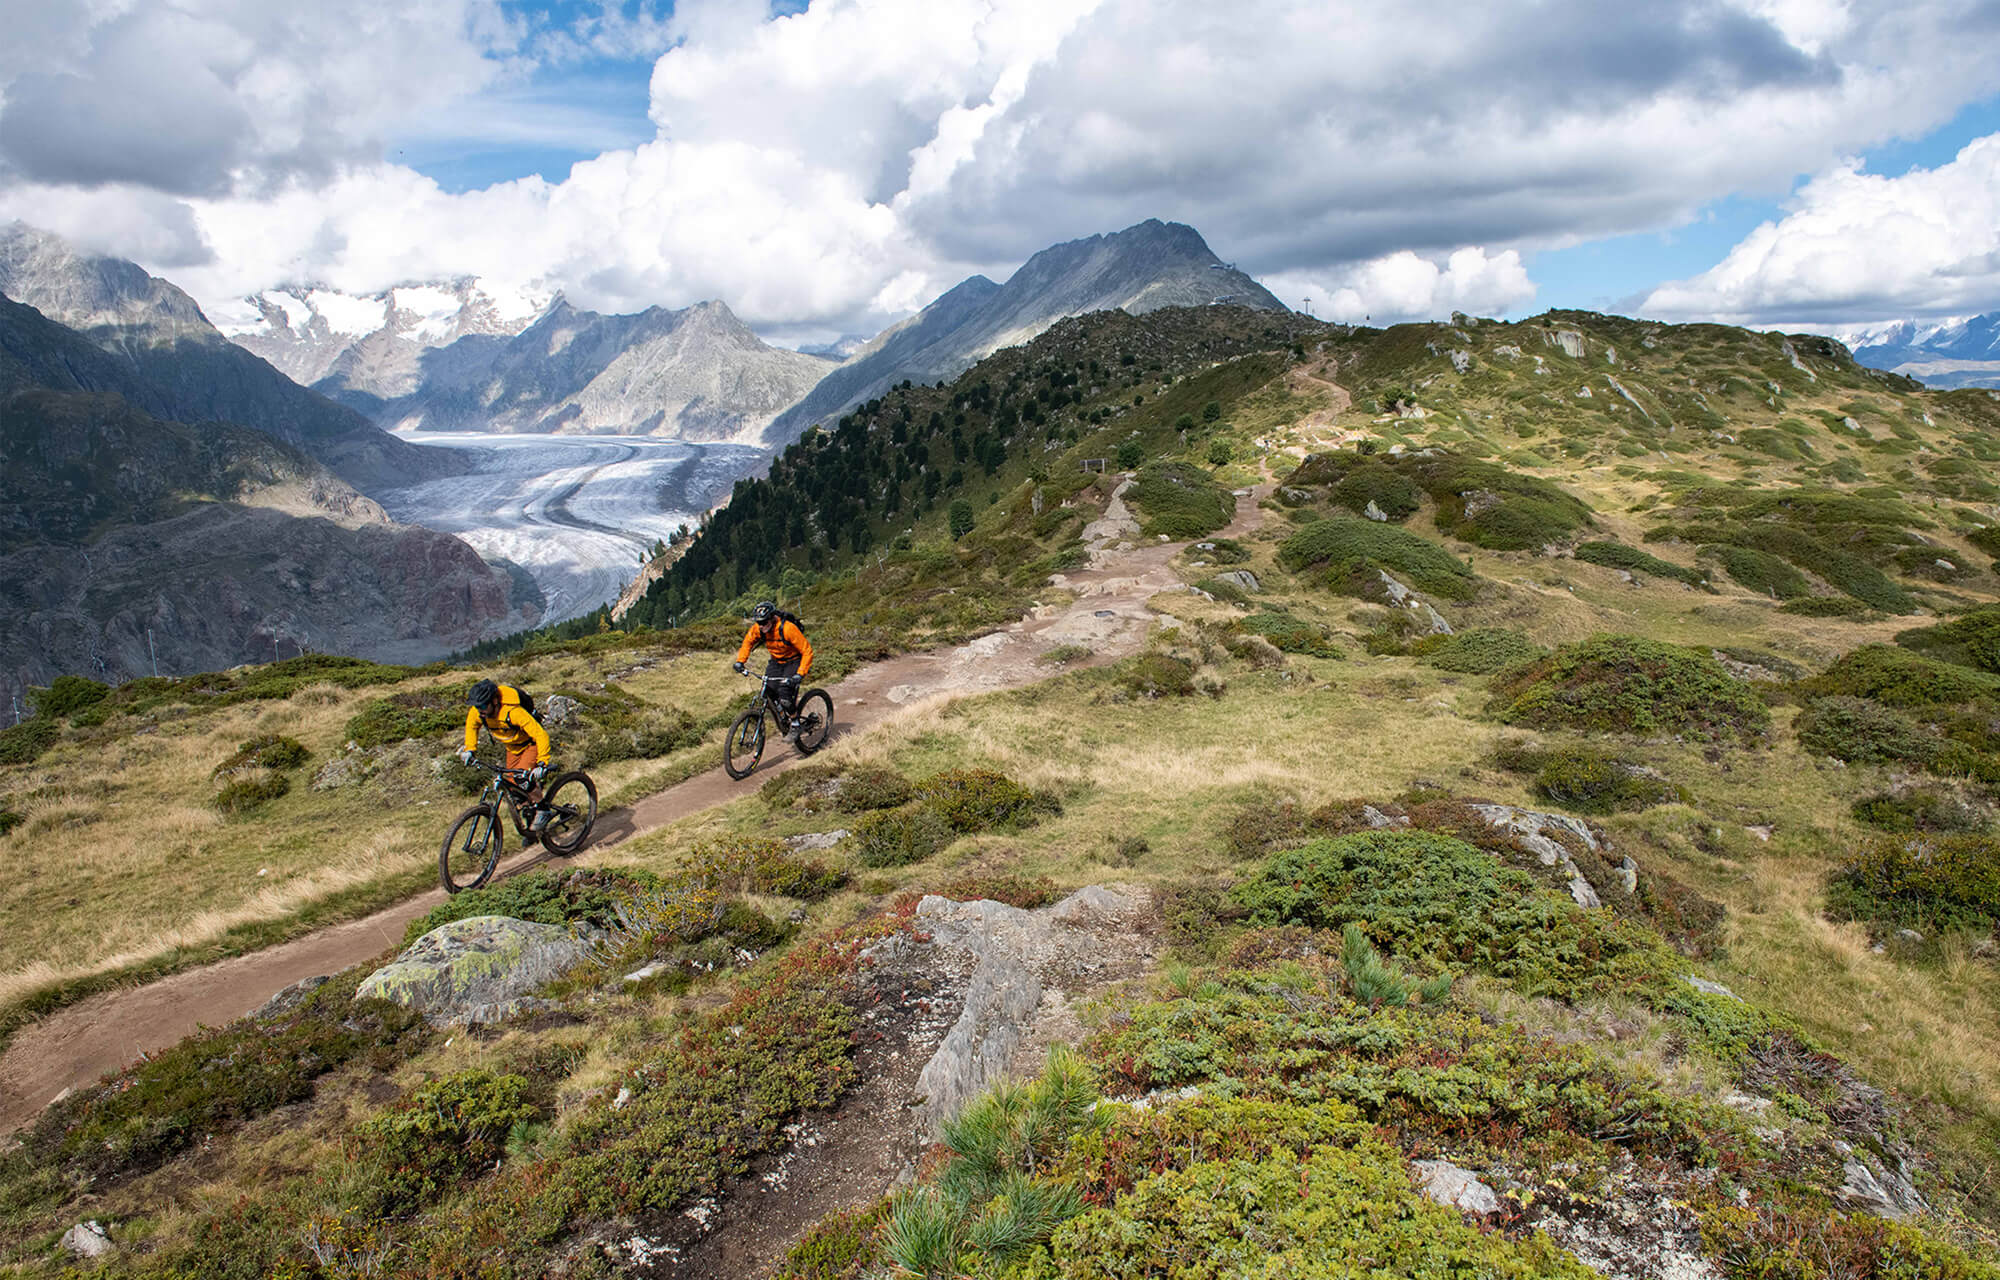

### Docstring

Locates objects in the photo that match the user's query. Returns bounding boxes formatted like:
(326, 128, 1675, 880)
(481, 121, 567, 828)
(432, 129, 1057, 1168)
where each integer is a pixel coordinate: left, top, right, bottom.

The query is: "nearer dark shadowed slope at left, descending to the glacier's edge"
(0, 298, 536, 682)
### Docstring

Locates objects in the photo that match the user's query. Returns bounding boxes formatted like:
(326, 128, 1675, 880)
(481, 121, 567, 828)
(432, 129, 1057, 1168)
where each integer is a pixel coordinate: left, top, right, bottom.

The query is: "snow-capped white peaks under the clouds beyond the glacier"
(220, 278, 552, 404)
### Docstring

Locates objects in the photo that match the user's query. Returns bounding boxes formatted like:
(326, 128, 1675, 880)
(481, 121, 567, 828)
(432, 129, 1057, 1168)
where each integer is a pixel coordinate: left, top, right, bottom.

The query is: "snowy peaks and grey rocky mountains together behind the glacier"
(234, 280, 828, 444)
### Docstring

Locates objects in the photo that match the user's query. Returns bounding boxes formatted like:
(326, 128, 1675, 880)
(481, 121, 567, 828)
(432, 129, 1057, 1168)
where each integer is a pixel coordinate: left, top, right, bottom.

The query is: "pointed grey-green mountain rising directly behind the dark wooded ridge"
(770, 218, 1284, 448)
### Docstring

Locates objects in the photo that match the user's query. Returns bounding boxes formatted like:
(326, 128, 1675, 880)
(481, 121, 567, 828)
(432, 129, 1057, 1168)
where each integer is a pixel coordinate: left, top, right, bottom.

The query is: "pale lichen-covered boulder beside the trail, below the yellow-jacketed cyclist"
(354, 916, 592, 1026)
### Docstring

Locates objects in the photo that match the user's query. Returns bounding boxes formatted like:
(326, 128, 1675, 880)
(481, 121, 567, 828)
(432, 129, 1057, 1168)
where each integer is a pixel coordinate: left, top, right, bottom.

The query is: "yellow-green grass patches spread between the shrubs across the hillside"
(0, 316, 2000, 1256)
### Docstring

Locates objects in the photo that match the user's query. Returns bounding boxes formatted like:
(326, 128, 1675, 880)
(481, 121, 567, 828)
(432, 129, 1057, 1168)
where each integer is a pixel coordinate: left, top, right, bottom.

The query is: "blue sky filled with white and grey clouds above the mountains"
(0, 0, 2000, 342)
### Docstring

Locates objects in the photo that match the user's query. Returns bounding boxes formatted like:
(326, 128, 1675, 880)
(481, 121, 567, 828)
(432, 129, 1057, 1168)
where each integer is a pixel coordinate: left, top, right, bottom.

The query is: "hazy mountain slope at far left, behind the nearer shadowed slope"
(0, 222, 458, 490)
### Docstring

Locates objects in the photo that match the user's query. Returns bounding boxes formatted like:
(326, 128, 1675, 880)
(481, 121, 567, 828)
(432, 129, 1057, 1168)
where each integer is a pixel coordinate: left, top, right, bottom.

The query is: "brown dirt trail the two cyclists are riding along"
(0, 482, 1268, 1134)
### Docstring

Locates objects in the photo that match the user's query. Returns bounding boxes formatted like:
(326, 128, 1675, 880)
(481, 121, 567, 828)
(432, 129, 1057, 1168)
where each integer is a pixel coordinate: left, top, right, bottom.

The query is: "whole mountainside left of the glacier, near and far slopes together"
(0, 228, 542, 692)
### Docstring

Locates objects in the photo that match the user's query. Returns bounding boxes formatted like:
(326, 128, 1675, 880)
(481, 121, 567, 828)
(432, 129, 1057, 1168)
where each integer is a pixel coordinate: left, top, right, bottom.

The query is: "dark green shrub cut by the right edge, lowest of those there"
(1826, 834, 2000, 932)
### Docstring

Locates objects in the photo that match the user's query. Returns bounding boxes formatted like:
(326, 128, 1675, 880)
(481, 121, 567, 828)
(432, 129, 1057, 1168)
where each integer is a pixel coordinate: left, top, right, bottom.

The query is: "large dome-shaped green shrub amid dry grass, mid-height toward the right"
(1494, 636, 1770, 740)
